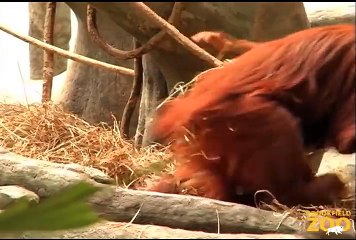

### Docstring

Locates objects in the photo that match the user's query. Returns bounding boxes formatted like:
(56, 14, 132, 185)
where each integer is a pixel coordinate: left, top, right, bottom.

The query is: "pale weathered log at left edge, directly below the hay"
(0, 147, 112, 198)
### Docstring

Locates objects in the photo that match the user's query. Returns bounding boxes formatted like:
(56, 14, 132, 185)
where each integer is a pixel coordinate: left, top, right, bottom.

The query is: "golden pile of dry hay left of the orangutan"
(0, 103, 174, 189)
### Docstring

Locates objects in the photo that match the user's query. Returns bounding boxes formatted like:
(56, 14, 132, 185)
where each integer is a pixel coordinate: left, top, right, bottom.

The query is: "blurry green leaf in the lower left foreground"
(0, 182, 99, 233)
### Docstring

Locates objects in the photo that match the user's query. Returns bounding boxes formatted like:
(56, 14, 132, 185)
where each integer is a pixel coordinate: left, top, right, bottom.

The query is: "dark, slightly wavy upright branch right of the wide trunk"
(120, 39, 143, 139)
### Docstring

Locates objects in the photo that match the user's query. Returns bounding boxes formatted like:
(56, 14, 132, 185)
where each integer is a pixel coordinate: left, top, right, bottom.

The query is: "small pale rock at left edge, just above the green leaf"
(0, 185, 40, 209)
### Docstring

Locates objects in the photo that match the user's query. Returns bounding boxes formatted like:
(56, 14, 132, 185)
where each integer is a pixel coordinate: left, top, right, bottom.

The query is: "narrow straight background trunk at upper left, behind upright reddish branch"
(28, 2, 71, 80)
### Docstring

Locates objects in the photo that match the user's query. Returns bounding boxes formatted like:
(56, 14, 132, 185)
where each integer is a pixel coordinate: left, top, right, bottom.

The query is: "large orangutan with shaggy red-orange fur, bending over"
(150, 25, 355, 206)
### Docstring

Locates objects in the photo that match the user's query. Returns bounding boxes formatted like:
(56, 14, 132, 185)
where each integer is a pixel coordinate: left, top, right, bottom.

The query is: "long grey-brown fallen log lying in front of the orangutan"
(90, 187, 302, 233)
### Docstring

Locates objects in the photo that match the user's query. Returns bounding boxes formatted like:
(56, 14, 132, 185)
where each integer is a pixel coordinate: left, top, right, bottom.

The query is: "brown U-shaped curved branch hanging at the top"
(87, 2, 183, 59)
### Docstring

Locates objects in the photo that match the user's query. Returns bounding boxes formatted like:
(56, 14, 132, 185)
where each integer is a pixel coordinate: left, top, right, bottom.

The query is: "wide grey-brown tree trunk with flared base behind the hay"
(59, 3, 137, 134)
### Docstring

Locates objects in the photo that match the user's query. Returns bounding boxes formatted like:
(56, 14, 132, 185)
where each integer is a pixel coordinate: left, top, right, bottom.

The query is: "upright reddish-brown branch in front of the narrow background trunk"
(42, 2, 56, 102)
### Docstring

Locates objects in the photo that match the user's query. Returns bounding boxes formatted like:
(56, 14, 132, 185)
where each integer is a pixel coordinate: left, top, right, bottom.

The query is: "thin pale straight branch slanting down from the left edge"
(0, 24, 135, 76)
